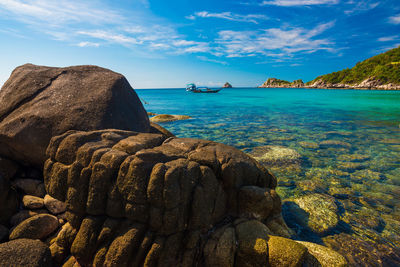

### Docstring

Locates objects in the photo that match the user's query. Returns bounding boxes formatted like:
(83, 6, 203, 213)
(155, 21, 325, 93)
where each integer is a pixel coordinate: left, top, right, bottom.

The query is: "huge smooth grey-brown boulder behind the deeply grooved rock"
(0, 64, 150, 166)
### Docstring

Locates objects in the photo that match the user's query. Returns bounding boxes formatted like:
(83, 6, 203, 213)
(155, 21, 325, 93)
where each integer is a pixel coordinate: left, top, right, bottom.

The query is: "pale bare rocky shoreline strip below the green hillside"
(305, 77, 400, 90)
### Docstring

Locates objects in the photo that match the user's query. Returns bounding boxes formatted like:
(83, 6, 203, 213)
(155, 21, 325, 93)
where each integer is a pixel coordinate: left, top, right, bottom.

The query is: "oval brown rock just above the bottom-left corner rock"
(10, 214, 58, 240)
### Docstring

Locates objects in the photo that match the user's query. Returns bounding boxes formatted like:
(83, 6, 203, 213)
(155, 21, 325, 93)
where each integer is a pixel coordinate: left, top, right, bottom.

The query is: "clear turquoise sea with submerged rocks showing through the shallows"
(136, 88, 400, 266)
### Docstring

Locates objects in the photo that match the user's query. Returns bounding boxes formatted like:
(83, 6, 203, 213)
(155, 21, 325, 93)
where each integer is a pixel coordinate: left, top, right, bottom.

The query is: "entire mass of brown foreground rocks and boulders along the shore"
(0, 64, 347, 267)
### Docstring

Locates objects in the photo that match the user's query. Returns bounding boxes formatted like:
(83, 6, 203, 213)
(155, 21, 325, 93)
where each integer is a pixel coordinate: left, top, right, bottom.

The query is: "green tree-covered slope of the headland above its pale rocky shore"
(307, 47, 400, 84)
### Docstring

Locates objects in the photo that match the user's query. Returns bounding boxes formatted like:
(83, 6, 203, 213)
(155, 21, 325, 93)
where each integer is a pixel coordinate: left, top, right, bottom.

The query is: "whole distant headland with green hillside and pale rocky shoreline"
(259, 47, 400, 90)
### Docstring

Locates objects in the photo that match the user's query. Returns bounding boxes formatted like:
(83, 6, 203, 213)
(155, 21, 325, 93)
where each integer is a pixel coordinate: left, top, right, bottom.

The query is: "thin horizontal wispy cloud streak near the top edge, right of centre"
(186, 11, 268, 24)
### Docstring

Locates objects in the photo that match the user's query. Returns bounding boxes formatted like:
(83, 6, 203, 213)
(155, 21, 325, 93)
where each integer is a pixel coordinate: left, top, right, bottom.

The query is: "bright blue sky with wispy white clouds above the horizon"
(0, 0, 400, 88)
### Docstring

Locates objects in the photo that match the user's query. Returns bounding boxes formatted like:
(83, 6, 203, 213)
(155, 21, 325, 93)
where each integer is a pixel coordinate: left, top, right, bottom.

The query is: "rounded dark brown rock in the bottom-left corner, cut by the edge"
(0, 239, 53, 267)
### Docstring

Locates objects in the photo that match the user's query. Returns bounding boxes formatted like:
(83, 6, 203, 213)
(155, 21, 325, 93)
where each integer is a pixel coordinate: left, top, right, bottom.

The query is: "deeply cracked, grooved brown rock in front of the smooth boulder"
(44, 130, 294, 266)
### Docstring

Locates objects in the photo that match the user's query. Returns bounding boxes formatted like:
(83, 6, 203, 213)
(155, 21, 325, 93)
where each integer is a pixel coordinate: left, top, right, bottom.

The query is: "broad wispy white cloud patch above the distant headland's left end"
(217, 22, 335, 57)
